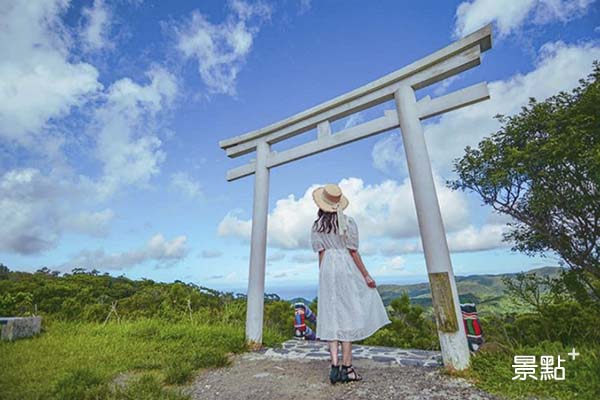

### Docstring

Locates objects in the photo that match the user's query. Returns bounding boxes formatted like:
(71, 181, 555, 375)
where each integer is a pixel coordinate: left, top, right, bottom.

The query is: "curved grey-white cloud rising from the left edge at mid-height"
(0, 67, 176, 254)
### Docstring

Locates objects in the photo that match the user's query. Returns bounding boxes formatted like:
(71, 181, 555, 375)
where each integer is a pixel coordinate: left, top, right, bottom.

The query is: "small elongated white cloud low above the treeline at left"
(58, 234, 188, 271)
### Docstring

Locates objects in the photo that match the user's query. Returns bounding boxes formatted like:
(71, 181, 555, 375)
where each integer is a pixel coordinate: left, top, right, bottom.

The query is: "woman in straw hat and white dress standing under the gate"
(311, 184, 392, 383)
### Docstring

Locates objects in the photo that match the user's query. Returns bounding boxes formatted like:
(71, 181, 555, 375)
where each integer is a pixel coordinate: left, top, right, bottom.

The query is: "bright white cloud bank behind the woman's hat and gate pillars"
(218, 178, 468, 249)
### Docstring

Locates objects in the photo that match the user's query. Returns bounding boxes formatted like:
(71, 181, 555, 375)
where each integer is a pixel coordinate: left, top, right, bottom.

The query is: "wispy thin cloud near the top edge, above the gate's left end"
(176, 0, 271, 95)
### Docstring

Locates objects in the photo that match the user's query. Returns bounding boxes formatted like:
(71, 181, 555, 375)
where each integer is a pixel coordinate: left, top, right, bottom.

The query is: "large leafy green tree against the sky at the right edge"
(447, 61, 600, 299)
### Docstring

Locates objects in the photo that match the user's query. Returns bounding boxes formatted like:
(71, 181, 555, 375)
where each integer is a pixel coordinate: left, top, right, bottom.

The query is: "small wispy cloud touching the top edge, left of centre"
(80, 0, 112, 51)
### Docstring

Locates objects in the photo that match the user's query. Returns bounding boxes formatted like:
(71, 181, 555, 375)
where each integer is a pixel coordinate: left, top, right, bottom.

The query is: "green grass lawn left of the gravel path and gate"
(0, 319, 285, 400)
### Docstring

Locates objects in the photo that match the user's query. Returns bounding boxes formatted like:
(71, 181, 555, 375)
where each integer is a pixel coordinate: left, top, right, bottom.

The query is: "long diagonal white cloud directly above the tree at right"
(373, 41, 600, 177)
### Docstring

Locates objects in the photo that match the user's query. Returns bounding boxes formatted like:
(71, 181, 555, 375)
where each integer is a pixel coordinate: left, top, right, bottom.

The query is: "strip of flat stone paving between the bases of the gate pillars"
(256, 339, 442, 367)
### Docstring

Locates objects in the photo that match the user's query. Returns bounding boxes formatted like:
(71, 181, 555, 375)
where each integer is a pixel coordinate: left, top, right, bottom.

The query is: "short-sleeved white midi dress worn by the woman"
(311, 217, 392, 341)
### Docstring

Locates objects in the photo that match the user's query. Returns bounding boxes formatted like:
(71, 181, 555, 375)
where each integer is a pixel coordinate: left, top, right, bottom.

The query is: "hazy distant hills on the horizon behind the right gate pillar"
(377, 267, 561, 312)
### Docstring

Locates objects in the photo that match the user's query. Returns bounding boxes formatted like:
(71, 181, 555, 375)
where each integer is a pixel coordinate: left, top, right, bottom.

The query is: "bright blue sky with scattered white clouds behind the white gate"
(0, 0, 600, 288)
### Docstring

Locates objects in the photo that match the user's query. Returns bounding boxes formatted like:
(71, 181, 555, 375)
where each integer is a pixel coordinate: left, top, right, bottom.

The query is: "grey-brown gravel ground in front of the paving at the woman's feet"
(186, 353, 499, 400)
